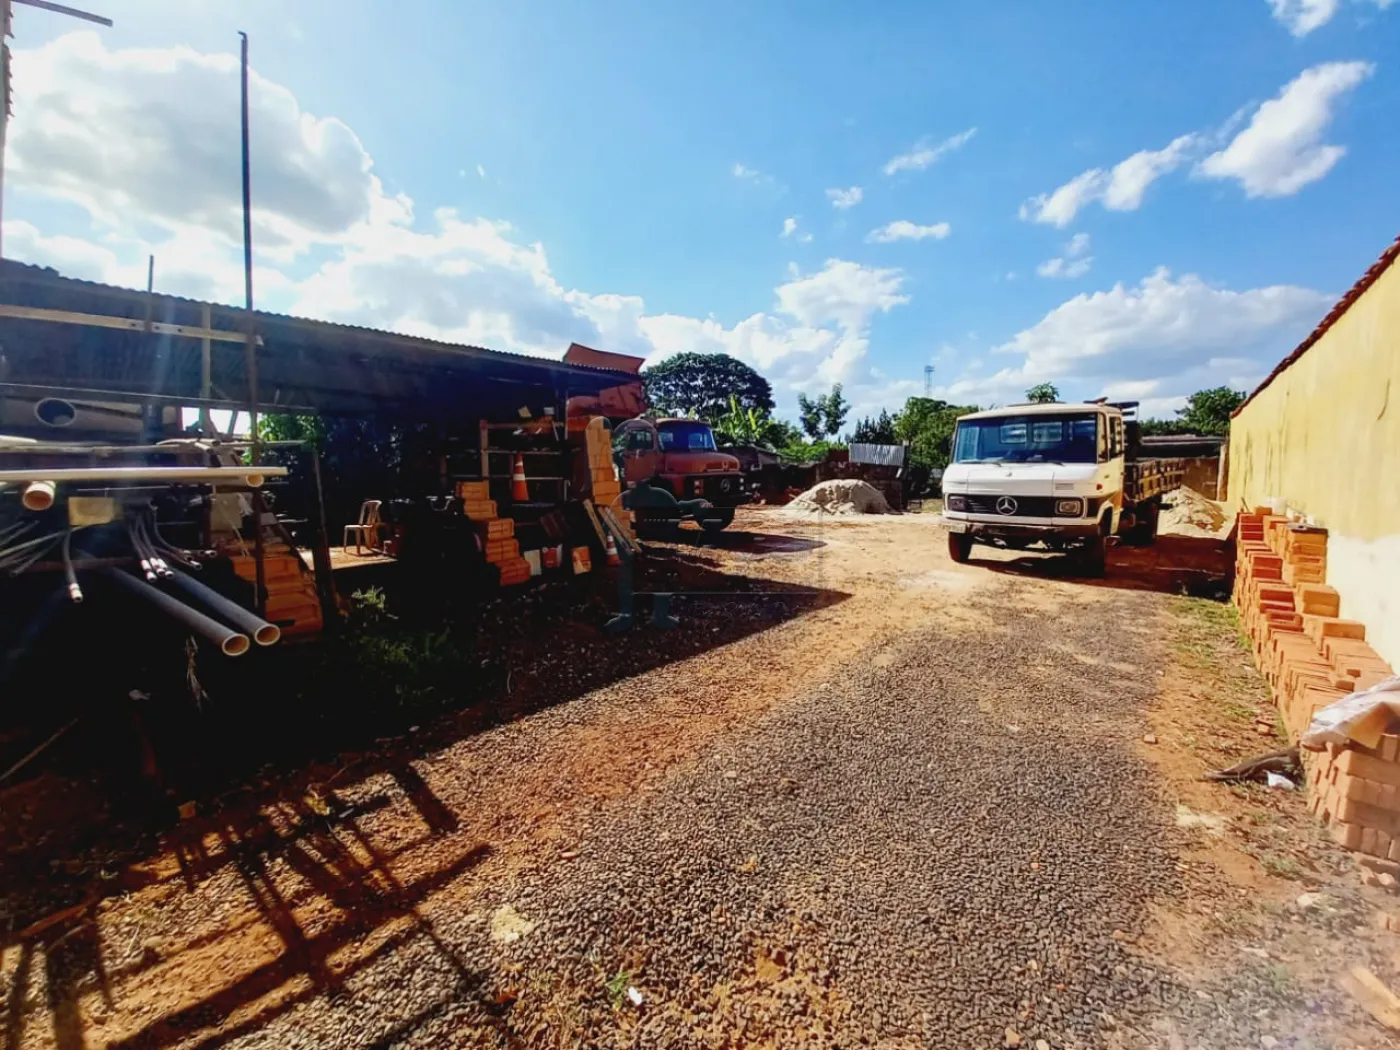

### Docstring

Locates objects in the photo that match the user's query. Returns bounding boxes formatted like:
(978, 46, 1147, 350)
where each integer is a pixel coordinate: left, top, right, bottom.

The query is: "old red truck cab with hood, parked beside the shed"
(613, 419, 749, 532)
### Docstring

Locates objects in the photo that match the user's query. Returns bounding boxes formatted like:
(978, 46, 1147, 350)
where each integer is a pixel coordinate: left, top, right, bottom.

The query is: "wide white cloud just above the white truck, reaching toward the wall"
(939, 267, 1333, 403)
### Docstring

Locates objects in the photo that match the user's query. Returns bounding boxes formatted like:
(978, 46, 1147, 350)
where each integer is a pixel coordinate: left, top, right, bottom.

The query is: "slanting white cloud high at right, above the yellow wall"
(1196, 62, 1375, 197)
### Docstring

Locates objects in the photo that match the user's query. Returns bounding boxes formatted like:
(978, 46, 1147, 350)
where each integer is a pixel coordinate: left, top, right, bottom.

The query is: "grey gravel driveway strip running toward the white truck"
(203, 579, 1176, 1047)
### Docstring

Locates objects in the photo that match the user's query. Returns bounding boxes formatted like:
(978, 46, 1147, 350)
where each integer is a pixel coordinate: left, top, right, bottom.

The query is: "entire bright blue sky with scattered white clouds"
(4, 0, 1400, 413)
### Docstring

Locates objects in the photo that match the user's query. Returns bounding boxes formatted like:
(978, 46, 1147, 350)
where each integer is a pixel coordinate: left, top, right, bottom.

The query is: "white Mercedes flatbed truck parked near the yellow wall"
(944, 400, 1182, 575)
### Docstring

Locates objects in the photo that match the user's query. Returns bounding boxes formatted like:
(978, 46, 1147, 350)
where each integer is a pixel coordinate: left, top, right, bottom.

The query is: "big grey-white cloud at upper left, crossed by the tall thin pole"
(7, 31, 407, 258)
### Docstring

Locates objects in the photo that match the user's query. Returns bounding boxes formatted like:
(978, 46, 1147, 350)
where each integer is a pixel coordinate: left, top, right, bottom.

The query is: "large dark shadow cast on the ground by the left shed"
(0, 533, 847, 1050)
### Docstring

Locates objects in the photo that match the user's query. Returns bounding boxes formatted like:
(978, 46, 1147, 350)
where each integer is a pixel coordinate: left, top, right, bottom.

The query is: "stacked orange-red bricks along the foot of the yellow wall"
(1235, 510, 1400, 861)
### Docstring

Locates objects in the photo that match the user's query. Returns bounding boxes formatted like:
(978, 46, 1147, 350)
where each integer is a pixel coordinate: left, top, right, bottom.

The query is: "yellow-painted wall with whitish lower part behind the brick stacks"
(1228, 263, 1400, 668)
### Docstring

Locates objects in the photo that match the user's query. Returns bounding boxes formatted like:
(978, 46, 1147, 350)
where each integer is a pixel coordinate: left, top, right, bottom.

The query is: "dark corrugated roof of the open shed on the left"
(0, 260, 637, 419)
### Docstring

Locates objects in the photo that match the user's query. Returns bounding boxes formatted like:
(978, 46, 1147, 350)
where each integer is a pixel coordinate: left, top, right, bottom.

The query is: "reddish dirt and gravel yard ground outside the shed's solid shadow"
(0, 508, 1400, 1050)
